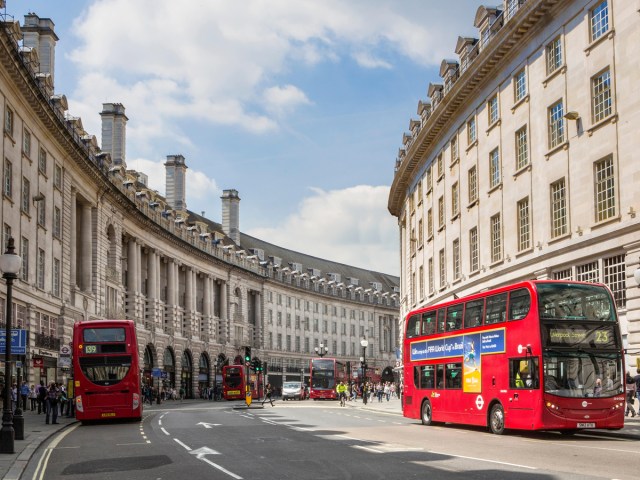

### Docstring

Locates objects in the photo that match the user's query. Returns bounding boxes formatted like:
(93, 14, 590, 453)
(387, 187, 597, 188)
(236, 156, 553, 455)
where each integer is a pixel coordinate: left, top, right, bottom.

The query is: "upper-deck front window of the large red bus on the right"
(537, 283, 616, 322)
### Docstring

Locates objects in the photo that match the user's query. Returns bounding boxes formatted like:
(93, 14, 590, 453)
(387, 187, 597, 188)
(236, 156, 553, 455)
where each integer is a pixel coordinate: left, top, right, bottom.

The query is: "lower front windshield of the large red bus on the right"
(544, 350, 624, 398)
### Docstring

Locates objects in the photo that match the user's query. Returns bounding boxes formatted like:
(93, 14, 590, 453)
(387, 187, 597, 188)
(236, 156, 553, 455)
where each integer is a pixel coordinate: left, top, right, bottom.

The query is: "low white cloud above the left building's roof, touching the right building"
(247, 185, 400, 275)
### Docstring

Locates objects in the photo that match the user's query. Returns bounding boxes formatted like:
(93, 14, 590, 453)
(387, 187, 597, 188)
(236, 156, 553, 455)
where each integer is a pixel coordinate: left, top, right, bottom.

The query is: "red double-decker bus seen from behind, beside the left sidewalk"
(73, 320, 142, 421)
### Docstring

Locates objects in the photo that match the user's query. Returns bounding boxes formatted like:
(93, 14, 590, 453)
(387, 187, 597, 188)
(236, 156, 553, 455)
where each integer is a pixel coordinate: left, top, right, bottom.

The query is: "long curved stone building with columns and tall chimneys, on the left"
(0, 9, 399, 397)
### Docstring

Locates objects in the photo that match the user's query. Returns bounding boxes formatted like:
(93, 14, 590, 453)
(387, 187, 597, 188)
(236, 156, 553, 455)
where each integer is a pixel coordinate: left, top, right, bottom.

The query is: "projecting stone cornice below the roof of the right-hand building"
(387, 0, 560, 217)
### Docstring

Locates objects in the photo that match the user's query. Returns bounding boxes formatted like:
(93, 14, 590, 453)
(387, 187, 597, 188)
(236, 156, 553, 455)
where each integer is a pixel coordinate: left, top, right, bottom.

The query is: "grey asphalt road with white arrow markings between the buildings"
(23, 401, 638, 480)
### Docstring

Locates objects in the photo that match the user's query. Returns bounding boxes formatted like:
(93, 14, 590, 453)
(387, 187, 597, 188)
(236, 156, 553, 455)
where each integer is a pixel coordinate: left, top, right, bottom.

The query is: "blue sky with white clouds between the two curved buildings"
(6, 0, 484, 275)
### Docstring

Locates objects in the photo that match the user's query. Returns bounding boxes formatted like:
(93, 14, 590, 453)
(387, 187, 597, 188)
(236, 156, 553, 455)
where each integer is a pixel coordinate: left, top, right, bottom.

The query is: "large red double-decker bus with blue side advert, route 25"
(402, 281, 625, 434)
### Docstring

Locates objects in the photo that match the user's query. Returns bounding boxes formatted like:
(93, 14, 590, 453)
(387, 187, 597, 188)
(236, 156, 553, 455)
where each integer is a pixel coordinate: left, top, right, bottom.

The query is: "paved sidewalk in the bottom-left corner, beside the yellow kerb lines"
(0, 410, 76, 480)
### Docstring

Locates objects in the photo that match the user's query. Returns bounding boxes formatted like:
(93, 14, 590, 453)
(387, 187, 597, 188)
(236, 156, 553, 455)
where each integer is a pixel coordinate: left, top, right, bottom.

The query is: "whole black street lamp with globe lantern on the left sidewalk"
(0, 237, 22, 453)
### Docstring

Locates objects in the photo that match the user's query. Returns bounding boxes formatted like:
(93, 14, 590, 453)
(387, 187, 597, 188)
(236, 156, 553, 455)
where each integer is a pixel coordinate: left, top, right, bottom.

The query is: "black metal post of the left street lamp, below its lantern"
(0, 264, 18, 453)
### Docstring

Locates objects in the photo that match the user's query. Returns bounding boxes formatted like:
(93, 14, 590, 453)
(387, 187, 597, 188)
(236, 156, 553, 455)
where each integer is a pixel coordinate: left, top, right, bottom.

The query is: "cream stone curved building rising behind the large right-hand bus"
(388, 0, 640, 366)
